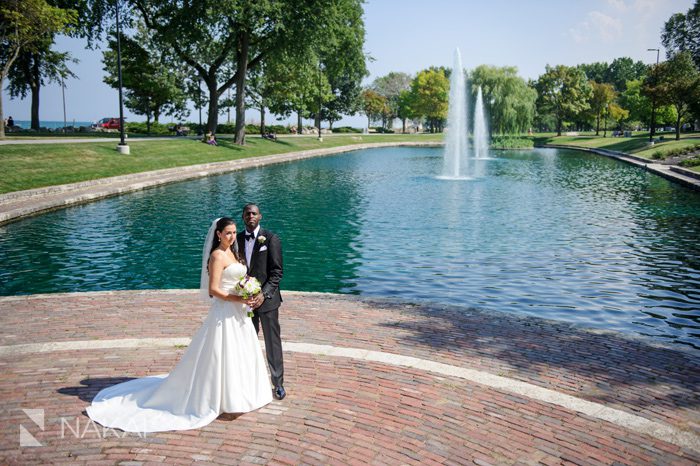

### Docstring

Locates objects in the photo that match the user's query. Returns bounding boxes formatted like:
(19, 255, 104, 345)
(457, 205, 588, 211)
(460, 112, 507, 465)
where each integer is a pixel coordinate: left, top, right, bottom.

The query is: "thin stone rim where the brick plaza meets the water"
(0, 288, 698, 357)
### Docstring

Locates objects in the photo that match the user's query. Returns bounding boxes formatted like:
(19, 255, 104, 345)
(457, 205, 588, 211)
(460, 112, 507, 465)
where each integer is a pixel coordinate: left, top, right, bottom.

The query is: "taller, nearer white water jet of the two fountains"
(441, 49, 469, 180)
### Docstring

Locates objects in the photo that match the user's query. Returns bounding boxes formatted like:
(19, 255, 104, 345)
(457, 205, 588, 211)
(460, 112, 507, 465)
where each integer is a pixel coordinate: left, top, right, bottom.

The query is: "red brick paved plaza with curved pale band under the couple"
(0, 290, 700, 465)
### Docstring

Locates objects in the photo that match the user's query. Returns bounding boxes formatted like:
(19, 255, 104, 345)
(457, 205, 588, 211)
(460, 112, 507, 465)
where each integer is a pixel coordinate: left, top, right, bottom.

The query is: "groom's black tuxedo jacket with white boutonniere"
(236, 227, 282, 312)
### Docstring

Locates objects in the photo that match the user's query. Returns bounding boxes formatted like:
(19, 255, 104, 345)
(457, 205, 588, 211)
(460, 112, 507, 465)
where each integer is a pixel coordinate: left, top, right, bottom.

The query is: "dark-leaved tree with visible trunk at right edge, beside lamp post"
(643, 52, 700, 140)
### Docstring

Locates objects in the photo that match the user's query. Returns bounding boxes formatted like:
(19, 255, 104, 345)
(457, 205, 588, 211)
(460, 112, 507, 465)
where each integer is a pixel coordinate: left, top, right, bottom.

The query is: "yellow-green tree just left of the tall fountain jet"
(411, 68, 450, 133)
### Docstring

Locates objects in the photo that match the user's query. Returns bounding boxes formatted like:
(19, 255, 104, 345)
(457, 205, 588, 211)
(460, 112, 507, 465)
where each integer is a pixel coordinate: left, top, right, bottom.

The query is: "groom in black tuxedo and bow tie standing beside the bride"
(236, 204, 287, 400)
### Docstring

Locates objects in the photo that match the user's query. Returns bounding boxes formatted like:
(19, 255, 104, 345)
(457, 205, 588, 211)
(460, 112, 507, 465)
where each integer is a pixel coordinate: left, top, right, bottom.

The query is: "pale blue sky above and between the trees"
(3, 0, 693, 126)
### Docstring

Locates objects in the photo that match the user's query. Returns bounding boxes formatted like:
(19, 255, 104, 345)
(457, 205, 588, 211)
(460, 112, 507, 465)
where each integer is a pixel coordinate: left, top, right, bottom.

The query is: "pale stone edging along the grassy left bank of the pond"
(0, 141, 442, 225)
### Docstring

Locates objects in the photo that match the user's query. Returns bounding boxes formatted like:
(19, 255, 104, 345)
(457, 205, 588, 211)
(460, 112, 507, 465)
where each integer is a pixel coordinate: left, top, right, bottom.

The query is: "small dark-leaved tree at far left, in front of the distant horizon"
(8, 40, 77, 130)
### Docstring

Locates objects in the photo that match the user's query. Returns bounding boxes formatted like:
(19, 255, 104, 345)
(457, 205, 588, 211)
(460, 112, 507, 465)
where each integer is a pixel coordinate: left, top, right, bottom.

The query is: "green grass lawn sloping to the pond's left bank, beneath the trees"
(0, 134, 443, 193)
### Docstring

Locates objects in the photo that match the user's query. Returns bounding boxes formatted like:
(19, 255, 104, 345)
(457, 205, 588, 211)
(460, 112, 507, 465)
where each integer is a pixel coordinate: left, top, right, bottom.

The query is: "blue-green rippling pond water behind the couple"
(0, 148, 700, 348)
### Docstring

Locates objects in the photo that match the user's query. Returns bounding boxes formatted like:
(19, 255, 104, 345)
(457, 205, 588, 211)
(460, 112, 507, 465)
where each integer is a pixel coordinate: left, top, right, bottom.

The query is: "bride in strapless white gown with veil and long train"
(87, 217, 272, 432)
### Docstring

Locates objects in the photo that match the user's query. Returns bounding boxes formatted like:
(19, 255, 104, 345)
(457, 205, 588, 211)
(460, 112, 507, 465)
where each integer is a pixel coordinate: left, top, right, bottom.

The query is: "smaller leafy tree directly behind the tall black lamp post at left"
(103, 27, 187, 131)
